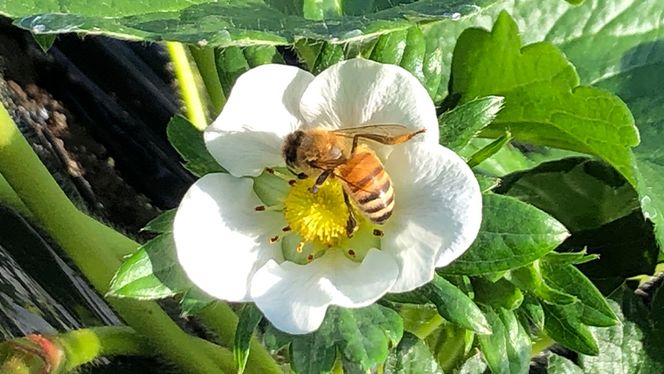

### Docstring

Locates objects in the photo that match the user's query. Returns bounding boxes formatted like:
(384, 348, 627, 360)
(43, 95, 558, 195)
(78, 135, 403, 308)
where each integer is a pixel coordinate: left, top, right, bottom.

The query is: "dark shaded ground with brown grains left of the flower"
(0, 19, 193, 234)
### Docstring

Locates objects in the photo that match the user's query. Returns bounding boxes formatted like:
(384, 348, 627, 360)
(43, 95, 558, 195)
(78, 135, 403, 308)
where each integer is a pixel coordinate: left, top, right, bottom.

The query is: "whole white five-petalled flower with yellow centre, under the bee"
(174, 59, 481, 334)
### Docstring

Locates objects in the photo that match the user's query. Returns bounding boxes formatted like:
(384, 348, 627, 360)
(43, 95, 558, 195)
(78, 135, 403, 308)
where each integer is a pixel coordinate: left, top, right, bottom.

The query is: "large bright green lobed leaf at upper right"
(451, 12, 639, 183)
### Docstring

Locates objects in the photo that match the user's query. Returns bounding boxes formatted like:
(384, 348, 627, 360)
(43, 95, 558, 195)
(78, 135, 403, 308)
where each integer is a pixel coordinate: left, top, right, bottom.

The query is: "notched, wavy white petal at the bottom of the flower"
(251, 249, 398, 334)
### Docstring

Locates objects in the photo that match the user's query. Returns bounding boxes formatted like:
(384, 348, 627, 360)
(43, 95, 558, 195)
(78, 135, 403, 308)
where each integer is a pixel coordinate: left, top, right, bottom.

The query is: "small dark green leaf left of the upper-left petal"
(166, 115, 225, 177)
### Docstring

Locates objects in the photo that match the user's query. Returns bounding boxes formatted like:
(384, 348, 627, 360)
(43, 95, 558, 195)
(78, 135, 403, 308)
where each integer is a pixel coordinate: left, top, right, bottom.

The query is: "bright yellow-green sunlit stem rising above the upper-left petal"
(166, 42, 207, 131)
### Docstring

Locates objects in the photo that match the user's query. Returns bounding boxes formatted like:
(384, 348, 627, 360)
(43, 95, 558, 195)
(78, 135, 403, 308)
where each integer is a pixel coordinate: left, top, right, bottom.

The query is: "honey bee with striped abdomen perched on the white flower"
(282, 124, 426, 236)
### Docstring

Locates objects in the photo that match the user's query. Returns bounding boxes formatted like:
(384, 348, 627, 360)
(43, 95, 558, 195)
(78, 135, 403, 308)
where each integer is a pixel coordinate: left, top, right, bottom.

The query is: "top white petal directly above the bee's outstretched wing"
(300, 59, 438, 143)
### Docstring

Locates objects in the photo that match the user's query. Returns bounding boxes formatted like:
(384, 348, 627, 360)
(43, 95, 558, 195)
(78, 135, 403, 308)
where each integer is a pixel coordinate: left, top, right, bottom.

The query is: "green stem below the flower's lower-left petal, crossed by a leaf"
(198, 302, 283, 374)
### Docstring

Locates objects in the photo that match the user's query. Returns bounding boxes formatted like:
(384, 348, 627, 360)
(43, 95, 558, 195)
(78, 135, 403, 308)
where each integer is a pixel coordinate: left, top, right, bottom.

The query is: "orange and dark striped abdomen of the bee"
(337, 149, 394, 224)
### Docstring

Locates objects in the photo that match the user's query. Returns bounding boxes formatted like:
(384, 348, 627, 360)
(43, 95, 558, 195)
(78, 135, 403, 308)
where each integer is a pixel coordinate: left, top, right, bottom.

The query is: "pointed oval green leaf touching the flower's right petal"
(441, 194, 568, 275)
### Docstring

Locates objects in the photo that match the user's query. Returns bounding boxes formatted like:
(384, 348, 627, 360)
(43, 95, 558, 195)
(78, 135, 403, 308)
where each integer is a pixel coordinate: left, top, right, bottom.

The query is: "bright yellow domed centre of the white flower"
(284, 178, 348, 246)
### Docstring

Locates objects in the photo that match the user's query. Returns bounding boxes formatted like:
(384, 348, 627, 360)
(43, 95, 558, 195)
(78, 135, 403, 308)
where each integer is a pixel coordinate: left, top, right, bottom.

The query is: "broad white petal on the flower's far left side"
(173, 174, 285, 301)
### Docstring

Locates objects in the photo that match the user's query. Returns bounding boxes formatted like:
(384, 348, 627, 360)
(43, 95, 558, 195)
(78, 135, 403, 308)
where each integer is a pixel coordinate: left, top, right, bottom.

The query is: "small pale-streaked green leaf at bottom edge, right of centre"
(477, 307, 531, 374)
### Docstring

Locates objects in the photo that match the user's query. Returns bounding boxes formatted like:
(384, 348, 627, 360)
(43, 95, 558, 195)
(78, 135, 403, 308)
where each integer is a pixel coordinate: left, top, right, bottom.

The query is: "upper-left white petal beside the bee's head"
(205, 64, 313, 176)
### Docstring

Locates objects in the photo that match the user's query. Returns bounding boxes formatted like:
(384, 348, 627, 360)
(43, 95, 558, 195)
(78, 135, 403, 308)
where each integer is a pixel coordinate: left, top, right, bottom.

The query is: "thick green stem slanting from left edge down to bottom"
(0, 106, 226, 373)
